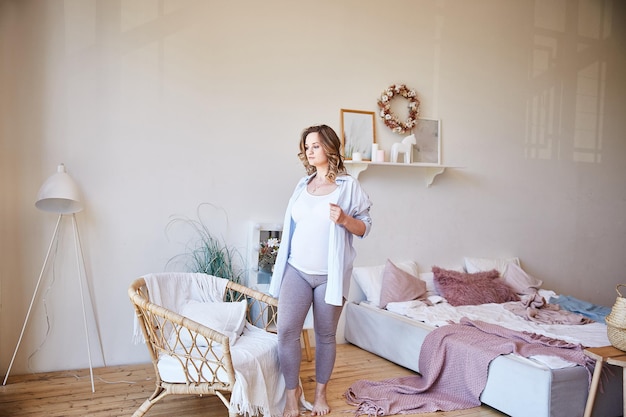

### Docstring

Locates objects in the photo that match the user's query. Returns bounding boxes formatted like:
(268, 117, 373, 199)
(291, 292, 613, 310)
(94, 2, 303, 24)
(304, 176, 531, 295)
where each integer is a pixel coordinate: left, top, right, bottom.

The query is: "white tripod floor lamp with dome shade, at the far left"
(2, 164, 100, 392)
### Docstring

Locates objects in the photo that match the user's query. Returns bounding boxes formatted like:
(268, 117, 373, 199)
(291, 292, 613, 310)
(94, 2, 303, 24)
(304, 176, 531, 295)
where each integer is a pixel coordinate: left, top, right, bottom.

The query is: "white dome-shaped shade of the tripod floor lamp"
(35, 164, 83, 214)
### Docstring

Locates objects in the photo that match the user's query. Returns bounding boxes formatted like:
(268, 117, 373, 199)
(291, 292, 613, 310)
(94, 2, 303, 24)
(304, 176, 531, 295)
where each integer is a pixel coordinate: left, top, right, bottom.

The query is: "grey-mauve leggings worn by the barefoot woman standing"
(278, 264, 342, 389)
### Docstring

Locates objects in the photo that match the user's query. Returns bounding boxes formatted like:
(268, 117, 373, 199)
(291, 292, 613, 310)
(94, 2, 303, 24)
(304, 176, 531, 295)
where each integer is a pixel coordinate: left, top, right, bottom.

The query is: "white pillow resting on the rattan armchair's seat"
(180, 300, 248, 346)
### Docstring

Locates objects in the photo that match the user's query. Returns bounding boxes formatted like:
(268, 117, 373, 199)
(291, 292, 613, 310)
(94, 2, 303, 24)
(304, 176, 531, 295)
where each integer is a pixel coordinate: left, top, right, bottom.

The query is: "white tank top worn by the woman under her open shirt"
(288, 188, 339, 275)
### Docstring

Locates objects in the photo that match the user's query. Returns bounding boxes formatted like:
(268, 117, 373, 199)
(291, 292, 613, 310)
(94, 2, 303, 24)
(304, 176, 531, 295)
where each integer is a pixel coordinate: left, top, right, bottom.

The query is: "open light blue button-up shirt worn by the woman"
(269, 174, 372, 306)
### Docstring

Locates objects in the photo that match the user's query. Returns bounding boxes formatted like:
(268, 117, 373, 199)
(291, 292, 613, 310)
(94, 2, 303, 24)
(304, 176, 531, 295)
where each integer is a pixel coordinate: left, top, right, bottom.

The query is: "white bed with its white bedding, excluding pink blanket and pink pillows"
(345, 258, 622, 417)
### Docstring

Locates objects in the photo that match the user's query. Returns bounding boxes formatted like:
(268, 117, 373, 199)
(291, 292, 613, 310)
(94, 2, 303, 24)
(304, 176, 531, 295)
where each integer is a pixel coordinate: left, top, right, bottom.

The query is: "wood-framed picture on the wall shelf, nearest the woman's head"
(341, 109, 376, 161)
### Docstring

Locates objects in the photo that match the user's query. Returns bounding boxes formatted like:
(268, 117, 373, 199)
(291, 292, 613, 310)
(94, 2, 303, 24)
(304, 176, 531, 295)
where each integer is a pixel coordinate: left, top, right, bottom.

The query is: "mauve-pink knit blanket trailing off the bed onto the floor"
(344, 318, 593, 416)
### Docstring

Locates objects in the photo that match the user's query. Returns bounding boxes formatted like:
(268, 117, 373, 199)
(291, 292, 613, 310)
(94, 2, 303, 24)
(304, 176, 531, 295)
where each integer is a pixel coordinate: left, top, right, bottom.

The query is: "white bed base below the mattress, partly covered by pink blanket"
(345, 302, 622, 417)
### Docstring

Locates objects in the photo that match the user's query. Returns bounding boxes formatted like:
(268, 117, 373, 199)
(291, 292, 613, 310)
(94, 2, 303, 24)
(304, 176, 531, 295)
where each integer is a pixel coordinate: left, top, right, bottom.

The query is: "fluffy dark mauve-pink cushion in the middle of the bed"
(433, 266, 519, 306)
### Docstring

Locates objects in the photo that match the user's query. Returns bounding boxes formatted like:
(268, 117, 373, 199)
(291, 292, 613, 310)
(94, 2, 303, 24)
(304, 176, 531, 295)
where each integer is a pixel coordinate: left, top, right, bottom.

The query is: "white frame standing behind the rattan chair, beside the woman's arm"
(248, 222, 283, 292)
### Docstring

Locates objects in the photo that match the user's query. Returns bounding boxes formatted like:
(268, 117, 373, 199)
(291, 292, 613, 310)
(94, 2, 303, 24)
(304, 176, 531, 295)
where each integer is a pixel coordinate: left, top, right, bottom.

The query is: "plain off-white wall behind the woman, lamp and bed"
(0, 0, 626, 374)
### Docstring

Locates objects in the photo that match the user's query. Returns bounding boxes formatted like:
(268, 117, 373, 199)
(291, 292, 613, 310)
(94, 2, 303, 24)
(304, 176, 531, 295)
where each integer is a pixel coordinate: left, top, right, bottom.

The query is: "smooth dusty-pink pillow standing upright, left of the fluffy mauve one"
(379, 259, 426, 308)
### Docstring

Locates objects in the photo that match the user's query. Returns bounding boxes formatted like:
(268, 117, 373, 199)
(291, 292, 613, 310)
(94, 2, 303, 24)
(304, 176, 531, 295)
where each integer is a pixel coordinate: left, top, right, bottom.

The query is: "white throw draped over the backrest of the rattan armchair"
(133, 272, 228, 344)
